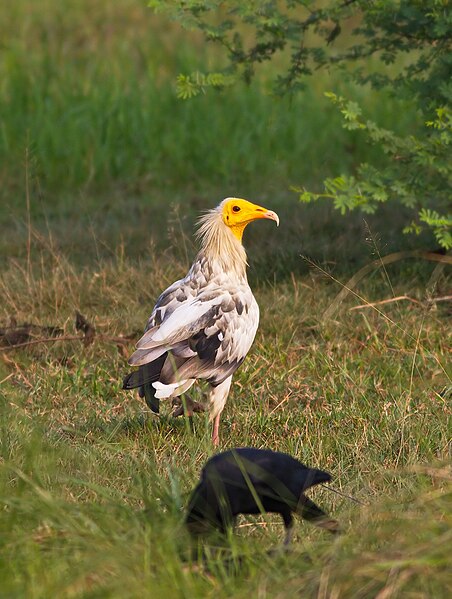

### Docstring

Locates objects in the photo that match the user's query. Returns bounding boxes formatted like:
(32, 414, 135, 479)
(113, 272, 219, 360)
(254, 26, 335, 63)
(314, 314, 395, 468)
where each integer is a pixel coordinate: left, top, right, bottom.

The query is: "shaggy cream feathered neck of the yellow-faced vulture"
(198, 210, 247, 279)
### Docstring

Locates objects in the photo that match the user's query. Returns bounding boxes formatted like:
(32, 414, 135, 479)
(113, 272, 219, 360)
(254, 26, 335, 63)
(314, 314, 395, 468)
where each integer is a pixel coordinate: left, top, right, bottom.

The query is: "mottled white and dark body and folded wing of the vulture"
(125, 264, 259, 385)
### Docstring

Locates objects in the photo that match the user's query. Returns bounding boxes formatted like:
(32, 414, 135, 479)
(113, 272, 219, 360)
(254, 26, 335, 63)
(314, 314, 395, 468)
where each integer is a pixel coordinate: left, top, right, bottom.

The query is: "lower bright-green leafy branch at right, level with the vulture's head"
(294, 98, 452, 249)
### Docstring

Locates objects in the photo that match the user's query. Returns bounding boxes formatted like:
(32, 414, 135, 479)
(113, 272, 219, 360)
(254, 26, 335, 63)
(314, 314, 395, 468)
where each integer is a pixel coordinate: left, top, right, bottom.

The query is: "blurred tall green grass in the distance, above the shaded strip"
(0, 0, 420, 210)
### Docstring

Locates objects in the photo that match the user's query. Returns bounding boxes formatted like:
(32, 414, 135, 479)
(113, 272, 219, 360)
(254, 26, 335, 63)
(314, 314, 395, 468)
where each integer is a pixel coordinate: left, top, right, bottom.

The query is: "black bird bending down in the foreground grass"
(186, 447, 339, 545)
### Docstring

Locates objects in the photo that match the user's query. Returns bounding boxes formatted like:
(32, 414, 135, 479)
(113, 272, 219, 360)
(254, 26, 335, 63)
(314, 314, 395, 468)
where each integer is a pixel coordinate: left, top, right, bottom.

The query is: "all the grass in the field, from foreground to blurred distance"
(0, 0, 452, 599)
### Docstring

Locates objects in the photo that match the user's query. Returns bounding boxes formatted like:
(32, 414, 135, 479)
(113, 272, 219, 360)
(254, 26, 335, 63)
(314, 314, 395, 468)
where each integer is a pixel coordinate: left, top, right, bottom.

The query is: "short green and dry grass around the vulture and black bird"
(0, 245, 451, 598)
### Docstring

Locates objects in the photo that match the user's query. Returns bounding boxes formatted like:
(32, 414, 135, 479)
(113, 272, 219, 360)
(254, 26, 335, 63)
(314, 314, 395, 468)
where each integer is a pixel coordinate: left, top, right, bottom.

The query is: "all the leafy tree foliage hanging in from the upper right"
(151, 0, 452, 249)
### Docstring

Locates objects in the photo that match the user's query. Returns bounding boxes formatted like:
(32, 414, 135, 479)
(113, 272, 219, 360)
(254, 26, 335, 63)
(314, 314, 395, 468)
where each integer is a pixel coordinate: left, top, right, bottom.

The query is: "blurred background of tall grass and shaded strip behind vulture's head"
(0, 0, 431, 274)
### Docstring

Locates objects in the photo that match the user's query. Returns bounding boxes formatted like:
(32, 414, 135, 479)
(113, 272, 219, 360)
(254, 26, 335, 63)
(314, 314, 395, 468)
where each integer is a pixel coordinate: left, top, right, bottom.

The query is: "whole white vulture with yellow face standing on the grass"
(123, 198, 279, 445)
